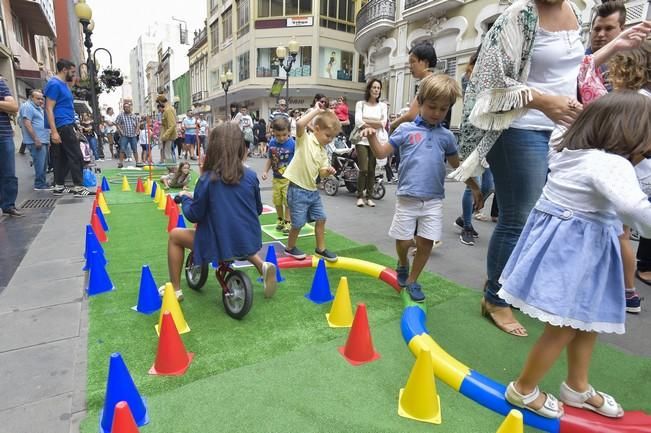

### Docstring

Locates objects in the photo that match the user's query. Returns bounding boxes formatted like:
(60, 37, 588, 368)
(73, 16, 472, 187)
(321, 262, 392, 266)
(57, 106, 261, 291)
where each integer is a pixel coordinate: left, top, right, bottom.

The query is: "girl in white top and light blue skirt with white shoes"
(498, 91, 651, 418)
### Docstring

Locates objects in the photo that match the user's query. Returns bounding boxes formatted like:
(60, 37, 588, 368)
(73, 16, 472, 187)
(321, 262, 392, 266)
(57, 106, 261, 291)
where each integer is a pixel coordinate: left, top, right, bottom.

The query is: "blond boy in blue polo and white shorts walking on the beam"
(370, 74, 483, 302)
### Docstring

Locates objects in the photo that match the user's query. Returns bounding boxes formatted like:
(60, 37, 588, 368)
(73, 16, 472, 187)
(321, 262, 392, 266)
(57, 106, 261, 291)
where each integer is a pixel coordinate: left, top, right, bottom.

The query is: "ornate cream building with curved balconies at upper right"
(355, 0, 608, 128)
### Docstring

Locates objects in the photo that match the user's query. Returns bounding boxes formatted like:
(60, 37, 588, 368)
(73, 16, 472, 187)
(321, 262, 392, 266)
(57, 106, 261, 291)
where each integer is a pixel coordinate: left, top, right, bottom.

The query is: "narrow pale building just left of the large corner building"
(188, 25, 212, 122)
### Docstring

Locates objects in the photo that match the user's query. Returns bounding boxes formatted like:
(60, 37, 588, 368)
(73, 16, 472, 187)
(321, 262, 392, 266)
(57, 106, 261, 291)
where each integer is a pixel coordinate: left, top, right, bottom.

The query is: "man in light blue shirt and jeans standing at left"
(19, 90, 50, 191)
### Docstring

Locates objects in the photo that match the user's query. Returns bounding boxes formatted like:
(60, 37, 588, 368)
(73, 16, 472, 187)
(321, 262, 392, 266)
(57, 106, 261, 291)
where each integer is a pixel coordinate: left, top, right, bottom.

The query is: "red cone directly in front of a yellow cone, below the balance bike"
(149, 311, 194, 376)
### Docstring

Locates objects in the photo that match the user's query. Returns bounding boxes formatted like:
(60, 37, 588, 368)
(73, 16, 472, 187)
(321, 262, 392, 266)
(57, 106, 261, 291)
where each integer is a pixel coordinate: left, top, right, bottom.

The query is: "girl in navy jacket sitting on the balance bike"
(160, 122, 276, 300)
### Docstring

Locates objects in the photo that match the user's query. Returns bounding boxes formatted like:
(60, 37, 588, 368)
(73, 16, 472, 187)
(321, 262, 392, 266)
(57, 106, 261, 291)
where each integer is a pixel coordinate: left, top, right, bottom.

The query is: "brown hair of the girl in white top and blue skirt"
(556, 90, 651, 158)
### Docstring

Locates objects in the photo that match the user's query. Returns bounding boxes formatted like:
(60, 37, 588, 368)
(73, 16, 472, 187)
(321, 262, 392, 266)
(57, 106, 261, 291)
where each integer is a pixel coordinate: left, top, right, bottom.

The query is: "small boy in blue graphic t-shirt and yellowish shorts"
(262, 116, 296, 234)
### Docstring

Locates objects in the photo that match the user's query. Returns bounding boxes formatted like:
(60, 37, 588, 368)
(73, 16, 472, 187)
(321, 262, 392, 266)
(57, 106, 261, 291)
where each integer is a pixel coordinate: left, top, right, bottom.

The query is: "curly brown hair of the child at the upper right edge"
(608, 40, 651, 90)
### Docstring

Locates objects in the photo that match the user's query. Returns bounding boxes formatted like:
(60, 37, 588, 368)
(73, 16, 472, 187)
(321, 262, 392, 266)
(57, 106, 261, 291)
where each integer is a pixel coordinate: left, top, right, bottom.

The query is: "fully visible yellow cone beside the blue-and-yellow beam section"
(398, 348, 441, 424)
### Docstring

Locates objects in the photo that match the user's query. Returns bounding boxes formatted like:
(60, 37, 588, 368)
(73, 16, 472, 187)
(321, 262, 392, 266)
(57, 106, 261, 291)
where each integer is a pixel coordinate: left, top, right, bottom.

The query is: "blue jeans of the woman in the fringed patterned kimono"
(484, 128, 551, 306)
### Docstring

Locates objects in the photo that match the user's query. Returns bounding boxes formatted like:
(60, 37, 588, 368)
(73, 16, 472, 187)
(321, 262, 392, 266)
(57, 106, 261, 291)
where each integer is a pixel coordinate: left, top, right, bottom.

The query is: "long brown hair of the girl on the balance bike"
(203, 122, 247, 184)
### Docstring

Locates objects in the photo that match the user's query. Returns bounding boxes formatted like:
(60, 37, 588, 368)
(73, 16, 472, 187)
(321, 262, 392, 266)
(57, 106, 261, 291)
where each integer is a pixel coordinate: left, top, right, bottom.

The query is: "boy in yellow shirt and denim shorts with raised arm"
(284, 103, 341, 262)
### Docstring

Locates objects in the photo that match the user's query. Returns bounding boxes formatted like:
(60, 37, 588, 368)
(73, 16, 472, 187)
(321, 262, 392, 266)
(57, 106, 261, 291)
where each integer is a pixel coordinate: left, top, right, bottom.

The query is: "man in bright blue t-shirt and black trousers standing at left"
(43, 59, 93, 197)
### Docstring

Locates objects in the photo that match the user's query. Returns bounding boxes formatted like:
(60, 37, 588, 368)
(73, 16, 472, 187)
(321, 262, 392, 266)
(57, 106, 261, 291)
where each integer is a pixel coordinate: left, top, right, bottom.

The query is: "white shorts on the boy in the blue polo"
(389, 196, 443, 241)
